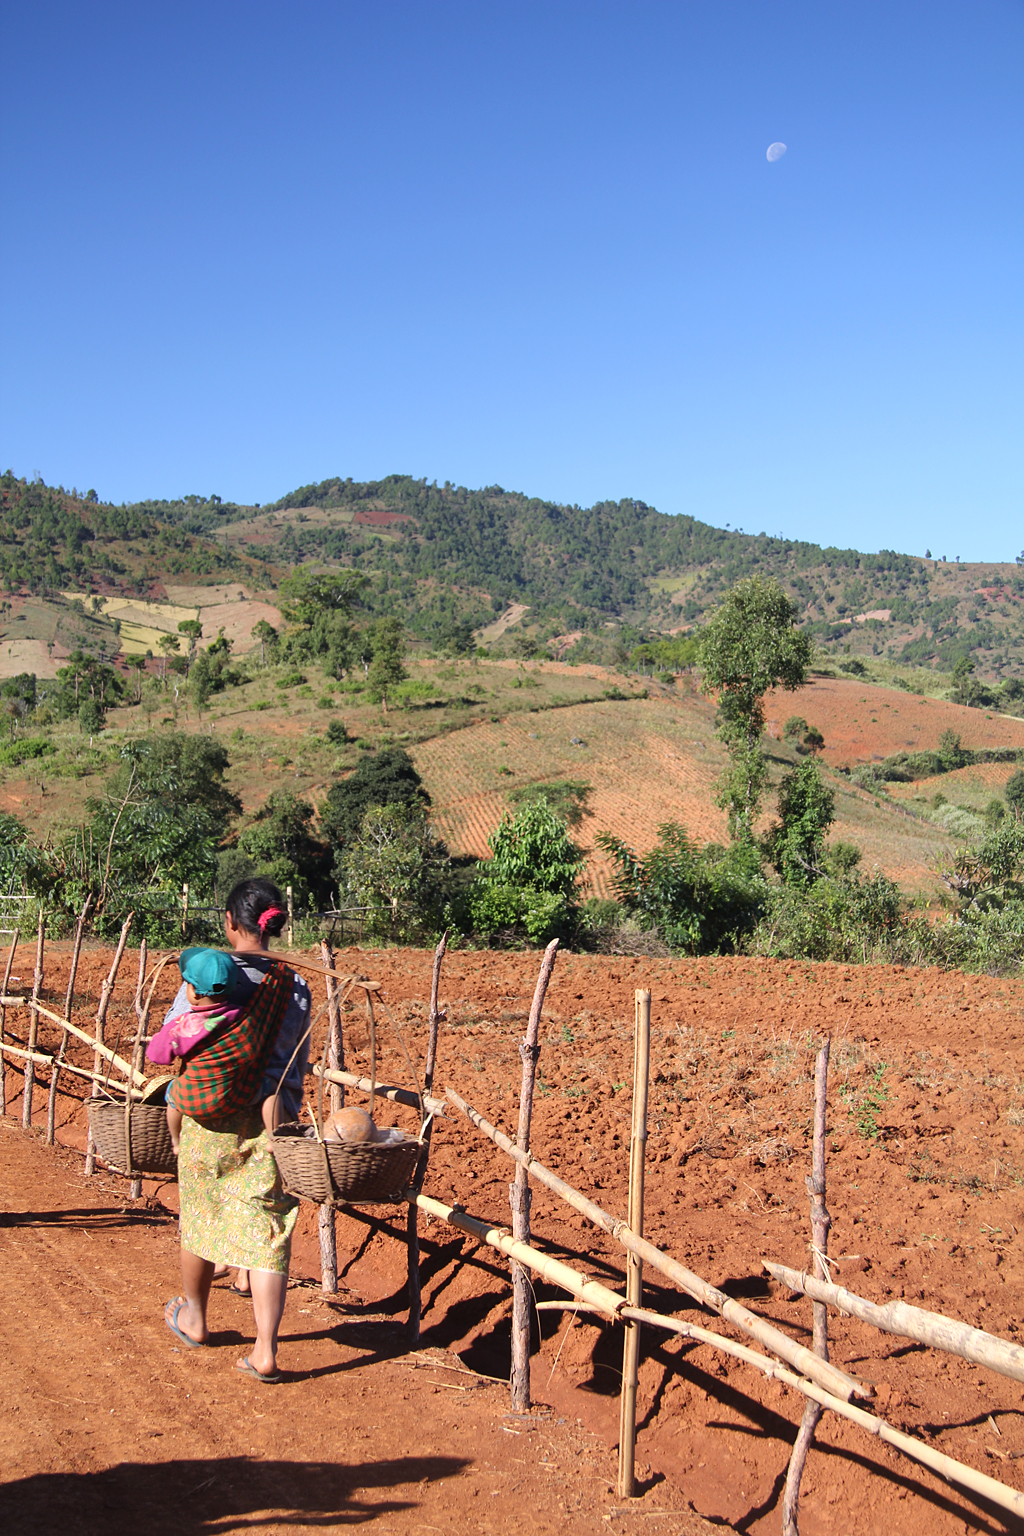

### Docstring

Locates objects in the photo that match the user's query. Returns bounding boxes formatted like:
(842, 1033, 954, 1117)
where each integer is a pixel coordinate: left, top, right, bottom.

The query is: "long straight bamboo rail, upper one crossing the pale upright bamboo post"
(447, 1087, 874, 1399)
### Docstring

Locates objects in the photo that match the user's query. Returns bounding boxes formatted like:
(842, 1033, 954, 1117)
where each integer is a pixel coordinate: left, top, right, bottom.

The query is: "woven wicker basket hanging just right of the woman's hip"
(270, 1124, 422, 1206)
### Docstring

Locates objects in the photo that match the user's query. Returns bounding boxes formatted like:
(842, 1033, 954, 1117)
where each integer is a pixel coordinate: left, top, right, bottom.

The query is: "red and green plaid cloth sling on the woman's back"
(167, 963, 293, 1120)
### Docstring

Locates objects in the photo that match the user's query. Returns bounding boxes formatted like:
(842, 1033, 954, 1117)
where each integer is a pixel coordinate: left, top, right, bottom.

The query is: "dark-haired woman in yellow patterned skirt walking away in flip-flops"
(164, 880, 310, 1382)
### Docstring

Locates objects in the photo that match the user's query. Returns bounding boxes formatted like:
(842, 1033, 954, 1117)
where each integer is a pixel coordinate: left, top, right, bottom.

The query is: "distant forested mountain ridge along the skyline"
(0, 475, 1024, 677)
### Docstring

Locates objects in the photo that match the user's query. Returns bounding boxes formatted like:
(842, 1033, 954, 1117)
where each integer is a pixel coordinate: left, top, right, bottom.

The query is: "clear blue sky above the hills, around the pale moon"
(0, 0, 1024, 559)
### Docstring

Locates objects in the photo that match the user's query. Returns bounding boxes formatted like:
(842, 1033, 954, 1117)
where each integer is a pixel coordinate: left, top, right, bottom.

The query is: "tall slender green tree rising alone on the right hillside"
(699, 576, 814, 840)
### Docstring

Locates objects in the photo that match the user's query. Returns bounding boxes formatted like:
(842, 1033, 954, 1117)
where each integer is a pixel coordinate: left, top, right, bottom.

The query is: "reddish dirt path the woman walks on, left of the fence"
(0, 1120, 721, 1536)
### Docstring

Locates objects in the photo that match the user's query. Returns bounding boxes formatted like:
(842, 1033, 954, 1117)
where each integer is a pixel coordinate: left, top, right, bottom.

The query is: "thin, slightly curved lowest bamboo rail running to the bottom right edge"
(537, 1301, 1024, 1516)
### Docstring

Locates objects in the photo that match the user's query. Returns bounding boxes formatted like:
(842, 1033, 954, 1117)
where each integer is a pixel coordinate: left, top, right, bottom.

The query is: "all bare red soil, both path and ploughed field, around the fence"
(0, 946, 1024, 1536)
